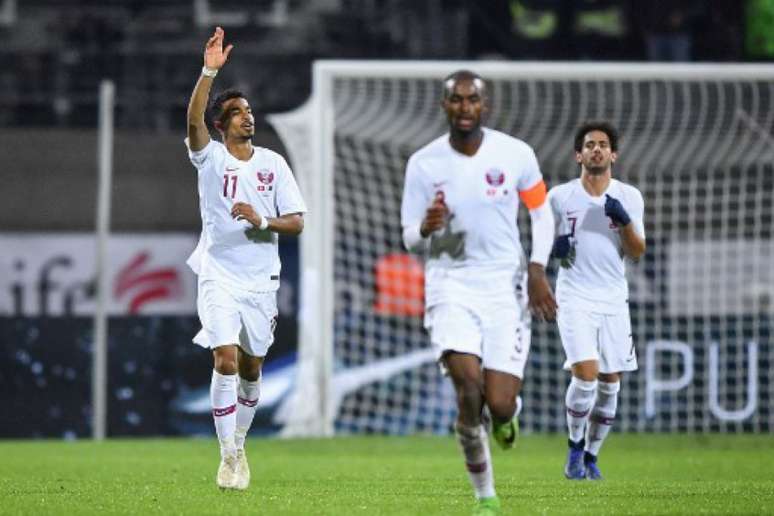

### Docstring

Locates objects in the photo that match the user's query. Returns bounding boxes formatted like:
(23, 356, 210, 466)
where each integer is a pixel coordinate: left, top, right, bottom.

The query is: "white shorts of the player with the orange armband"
(425, 299, 532, 378)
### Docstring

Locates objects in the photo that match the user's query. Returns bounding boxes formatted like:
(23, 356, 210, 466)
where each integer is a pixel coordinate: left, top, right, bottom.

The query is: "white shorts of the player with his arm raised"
(193, 280, 277, 357)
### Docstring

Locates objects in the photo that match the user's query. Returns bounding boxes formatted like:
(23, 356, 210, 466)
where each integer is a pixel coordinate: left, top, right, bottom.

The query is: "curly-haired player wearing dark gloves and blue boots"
(548, 122, 645, 480)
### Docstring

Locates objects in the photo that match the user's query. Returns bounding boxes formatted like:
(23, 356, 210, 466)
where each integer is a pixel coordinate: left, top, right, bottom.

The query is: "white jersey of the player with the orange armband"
(401, 128, 543, 307)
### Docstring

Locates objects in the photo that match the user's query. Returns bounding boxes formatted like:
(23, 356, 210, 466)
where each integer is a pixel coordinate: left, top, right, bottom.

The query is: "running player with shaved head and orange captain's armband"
(401, 70, 556, 514)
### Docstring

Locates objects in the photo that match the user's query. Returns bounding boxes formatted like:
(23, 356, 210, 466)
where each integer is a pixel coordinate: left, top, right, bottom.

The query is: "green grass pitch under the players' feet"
(0, 434, 774, 515)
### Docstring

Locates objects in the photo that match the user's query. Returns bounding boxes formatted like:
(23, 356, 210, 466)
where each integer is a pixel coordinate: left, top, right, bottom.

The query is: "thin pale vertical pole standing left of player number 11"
(91, 80, 115, 441)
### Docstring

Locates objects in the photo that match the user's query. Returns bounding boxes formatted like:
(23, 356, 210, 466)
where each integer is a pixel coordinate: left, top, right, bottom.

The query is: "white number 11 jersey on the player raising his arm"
(186, 139, 306, 292)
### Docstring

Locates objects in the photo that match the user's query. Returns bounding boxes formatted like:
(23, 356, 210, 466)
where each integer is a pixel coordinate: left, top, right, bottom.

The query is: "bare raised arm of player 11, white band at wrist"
(188, 27, 234, 151)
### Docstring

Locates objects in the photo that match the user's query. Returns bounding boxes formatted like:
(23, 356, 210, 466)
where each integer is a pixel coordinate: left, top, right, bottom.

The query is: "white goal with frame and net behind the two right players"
(270, 61, 774, 435)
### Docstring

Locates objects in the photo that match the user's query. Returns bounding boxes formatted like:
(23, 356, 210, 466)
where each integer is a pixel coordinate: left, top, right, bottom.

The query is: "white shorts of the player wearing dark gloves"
(556, 305, 637, 373)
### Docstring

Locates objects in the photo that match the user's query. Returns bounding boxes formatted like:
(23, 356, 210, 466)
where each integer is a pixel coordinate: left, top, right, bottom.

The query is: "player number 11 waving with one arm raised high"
(186, 27, 306, 489)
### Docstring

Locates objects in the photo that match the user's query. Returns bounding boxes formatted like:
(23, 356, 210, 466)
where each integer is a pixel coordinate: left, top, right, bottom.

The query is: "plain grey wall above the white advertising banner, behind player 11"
(0, 127, 285, 232)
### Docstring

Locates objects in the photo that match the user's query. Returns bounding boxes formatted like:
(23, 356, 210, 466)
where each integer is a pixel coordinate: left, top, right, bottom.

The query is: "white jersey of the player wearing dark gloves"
(548, 179, 645, 314)
